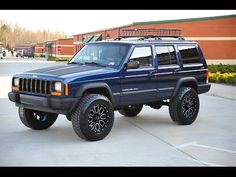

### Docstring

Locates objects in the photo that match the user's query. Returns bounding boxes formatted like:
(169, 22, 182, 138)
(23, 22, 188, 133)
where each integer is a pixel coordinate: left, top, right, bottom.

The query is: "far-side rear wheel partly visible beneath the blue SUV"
(119, 104, 143, 117)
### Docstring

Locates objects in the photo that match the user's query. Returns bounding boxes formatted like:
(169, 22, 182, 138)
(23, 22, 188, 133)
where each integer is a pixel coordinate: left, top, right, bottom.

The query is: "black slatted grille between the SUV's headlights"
(19, 78, 51, 94)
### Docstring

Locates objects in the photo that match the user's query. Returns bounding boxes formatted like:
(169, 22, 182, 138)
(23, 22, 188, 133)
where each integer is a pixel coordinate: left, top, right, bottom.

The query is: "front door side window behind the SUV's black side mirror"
(130, 47, 152, 68)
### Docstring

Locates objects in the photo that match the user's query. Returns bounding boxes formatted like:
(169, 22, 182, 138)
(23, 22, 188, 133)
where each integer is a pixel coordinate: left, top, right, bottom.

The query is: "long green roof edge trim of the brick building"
(73, 14, 236, 36)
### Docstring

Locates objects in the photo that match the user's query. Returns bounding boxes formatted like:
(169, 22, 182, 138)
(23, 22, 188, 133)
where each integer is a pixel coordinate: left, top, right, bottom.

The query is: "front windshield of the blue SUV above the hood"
(69, 43, 129, 68)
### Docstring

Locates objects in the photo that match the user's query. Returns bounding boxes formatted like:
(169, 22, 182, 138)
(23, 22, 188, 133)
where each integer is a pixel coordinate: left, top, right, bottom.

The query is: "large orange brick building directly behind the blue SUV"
(73, 15, 236, 63)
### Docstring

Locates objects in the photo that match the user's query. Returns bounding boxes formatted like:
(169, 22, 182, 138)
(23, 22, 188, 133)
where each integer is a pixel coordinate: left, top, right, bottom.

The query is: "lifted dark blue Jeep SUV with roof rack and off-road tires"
(8, 29, 210, 141)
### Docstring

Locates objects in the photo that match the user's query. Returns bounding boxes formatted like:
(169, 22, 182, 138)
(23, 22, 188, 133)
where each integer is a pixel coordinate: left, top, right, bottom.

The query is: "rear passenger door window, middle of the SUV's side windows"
(155, 46, 177, 66)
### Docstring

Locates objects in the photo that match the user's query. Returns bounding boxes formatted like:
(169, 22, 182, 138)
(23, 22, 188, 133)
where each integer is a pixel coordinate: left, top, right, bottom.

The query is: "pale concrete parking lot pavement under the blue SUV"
(0, 58, 236, 166)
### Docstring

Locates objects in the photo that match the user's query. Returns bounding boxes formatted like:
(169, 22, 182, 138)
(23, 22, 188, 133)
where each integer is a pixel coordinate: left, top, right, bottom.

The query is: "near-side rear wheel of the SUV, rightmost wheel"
(169, 87, 199, 125)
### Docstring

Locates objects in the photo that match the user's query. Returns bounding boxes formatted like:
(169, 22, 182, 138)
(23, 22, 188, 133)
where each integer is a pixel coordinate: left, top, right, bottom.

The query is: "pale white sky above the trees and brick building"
(0, 10, 236, 36)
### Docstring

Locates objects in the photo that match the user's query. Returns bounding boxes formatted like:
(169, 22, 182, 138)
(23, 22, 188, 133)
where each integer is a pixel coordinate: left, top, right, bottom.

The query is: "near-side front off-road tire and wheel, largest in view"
(71, 94, 114, 141)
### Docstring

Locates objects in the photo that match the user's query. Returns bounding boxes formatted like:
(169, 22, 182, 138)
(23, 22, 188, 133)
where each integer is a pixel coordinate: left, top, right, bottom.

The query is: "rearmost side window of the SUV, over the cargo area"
(178, 45, 201, 64)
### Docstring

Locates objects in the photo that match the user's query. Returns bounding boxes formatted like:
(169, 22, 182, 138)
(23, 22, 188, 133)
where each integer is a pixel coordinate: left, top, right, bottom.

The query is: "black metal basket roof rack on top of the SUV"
(115, 28, 184, 40)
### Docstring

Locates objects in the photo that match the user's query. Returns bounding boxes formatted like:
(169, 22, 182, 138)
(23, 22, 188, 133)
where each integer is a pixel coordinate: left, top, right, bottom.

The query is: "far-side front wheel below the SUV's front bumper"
(18, 107, 58, 130)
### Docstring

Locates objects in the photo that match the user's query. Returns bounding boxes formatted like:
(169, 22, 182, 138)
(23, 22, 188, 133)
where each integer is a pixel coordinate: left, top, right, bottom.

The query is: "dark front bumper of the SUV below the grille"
(8, 92, 79, 114)
